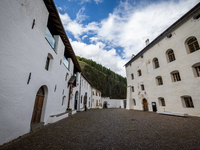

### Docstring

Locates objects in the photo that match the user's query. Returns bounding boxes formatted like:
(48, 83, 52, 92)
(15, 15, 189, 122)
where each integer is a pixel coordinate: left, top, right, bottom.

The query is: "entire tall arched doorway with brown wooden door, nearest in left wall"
(31, 86, 45, 124)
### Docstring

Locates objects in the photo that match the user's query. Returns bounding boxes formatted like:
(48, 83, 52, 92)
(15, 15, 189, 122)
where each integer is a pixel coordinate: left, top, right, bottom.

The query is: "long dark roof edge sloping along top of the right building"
(125, 2, 200, 67)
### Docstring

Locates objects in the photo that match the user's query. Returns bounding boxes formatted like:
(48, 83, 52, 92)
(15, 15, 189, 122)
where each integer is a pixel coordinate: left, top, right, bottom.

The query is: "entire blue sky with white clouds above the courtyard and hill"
(54, 0, 200, 77)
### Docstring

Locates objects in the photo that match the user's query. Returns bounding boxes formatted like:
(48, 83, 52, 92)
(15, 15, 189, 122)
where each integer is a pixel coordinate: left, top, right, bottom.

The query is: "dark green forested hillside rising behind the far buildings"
(77, 56, 126, 99)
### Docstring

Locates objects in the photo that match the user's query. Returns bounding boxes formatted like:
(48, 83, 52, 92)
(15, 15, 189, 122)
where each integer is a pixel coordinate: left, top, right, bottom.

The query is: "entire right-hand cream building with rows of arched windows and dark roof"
(125, 3, 200, 116)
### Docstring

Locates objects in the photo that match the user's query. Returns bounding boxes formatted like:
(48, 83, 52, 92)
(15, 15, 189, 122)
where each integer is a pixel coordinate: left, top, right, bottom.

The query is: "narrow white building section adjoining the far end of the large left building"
(79, 74, 92, 111)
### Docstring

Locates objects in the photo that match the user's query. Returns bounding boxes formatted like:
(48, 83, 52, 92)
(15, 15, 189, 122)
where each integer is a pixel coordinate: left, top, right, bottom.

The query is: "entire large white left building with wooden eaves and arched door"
(0, 0, 82, 145)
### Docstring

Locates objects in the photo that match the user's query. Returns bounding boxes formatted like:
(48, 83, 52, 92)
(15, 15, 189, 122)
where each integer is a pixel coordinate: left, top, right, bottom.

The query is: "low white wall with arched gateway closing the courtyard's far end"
(101, 97, 126, 108)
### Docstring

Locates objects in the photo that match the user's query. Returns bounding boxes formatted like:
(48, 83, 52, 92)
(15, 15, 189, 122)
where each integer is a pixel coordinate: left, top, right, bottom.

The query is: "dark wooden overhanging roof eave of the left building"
(43, 0, 82, 72)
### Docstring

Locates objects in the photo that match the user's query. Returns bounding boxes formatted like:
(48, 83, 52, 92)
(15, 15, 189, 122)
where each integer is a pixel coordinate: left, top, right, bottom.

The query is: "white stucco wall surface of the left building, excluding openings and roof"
(0, 0, 79, 145)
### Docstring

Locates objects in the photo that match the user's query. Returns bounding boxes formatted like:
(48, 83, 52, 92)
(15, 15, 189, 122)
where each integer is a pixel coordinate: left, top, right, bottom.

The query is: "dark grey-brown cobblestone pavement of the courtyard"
(0, 109, 200, 150)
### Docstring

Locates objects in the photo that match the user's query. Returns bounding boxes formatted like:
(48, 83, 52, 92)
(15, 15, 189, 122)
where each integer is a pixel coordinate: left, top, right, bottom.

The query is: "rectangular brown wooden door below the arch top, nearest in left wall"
(31, 95, 44, 124)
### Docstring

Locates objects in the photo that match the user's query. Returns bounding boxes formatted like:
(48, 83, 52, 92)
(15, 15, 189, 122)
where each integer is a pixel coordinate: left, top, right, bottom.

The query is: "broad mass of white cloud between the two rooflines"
(57, 0, 199, 76)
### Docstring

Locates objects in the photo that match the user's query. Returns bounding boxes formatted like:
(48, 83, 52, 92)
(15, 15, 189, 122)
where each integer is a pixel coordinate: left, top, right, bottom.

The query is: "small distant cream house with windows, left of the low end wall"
(91, 87, 102, 108)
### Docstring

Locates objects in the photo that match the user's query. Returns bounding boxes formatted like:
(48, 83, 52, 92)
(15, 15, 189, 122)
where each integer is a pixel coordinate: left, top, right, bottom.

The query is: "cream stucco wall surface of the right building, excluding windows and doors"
(126, 13, 200, 116)
